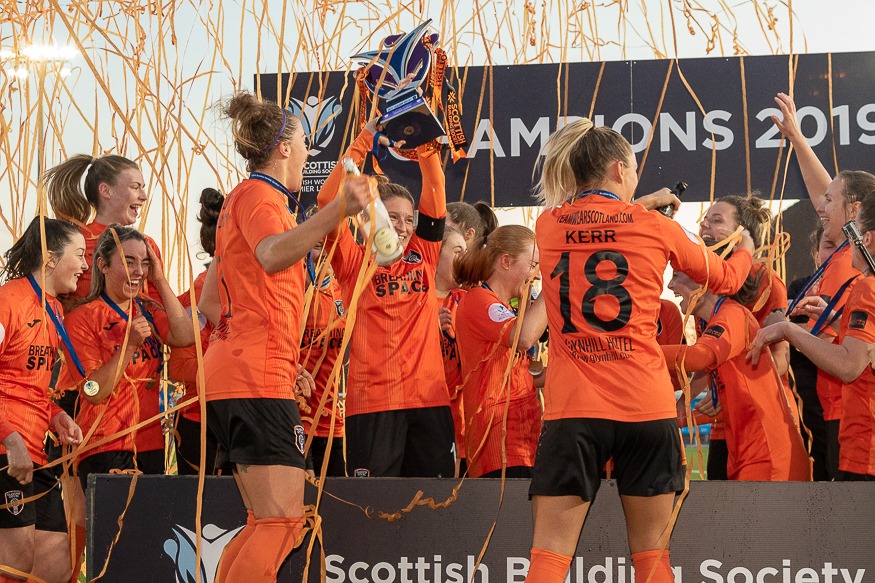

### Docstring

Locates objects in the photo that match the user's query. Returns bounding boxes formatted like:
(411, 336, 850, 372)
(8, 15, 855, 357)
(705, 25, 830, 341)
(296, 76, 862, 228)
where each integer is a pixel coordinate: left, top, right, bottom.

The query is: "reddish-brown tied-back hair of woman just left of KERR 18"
(453, 225, 535, 287)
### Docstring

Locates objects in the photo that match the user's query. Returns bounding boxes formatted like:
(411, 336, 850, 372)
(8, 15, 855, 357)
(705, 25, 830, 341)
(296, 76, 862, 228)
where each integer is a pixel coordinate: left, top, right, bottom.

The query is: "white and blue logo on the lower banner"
(164, 524, 243, 583)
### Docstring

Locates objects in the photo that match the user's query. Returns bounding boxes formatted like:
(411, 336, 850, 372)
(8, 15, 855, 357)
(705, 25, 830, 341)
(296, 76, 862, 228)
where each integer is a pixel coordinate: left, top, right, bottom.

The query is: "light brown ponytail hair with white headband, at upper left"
(41, 154, 140, 224)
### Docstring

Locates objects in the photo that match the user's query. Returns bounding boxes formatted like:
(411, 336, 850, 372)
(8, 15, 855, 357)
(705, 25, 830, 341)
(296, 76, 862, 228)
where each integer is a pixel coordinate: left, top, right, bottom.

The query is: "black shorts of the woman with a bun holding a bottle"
(207, 399, 307, 470)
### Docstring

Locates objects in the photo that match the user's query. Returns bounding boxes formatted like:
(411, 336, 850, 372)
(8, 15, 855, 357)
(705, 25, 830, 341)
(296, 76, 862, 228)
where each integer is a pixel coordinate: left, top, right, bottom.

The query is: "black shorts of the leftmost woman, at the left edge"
(0, 454, 67, 532)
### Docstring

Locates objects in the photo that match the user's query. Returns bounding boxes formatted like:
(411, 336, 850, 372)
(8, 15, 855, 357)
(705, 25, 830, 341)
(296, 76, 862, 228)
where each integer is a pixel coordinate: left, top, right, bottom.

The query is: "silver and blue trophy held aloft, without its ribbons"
(352, 20, 445, 149)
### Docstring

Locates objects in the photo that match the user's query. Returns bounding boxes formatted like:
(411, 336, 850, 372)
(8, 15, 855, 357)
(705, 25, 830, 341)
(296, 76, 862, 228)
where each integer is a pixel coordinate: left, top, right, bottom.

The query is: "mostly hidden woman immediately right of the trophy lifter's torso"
(434, 226, 470, 477)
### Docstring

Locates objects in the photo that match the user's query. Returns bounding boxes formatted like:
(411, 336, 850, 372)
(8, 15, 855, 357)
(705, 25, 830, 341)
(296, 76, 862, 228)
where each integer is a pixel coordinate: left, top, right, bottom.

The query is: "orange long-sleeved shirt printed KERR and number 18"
(535, 194, 751, 421)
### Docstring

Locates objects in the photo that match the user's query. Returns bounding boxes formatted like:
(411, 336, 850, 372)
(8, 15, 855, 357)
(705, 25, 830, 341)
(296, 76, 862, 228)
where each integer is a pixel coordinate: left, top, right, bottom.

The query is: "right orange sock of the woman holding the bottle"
(219, 518, 304, 583)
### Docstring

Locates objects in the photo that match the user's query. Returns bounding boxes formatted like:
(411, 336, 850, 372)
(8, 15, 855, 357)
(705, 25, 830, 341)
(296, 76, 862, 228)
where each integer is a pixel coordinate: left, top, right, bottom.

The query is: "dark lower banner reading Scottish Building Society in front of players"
(87, 476, 875, 583)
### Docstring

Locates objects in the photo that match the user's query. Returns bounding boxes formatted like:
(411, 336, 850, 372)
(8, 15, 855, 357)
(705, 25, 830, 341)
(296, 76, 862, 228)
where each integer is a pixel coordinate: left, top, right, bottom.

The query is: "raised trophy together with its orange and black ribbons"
(352, 20, 467, 172)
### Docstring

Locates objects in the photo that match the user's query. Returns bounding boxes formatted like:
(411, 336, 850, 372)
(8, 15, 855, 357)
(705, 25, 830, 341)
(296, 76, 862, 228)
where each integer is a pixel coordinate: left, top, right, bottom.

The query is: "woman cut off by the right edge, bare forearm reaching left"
(750, 194, 875, 481)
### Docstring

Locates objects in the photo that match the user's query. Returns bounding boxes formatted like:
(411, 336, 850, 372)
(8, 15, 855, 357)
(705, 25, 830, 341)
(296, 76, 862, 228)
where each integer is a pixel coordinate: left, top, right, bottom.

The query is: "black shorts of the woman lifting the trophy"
(344, 407, 456, 478)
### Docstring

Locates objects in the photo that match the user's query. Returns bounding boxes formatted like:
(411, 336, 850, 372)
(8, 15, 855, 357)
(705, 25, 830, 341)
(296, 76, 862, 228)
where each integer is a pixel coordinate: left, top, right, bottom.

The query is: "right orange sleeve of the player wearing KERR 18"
(658, 215, 752, 295)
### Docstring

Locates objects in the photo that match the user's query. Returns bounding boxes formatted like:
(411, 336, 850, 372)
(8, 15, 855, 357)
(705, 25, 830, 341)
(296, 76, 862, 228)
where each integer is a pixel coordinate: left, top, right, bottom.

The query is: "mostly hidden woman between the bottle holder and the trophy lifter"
(301, 237, 346, 476)
